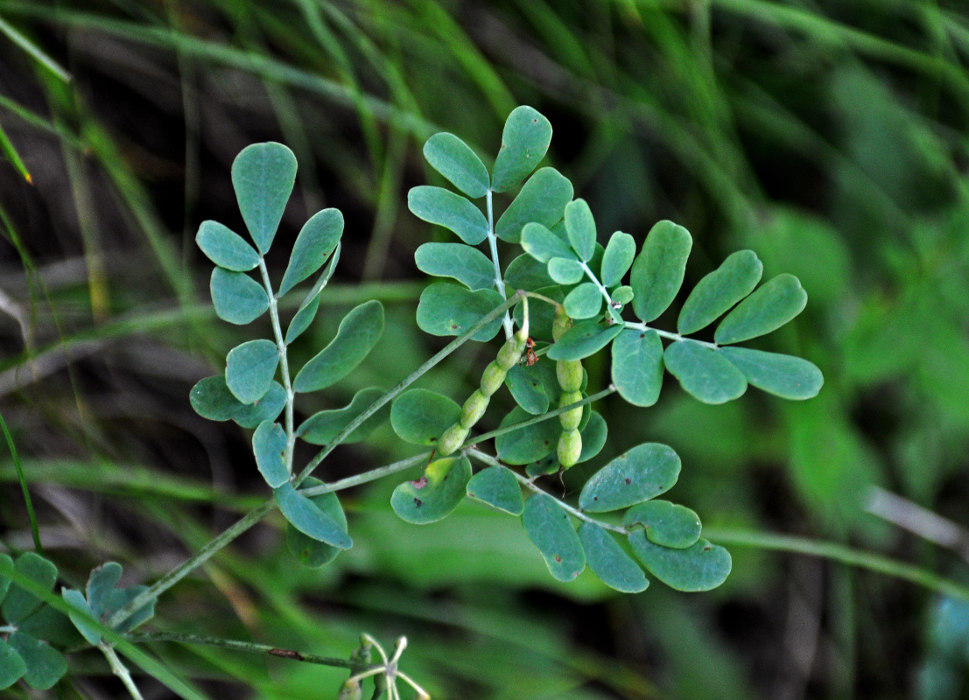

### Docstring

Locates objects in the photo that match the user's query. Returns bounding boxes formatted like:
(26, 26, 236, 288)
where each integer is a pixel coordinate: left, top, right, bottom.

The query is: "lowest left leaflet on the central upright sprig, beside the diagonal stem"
(417, 282, 504, 342)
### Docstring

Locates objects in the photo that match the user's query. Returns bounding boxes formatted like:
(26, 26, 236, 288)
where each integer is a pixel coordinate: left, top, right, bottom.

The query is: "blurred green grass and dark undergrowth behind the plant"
(0, 0, 969, 699)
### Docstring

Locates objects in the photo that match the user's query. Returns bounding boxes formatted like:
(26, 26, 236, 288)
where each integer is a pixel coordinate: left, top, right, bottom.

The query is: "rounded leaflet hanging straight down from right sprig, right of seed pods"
(611, 328, 664, 406)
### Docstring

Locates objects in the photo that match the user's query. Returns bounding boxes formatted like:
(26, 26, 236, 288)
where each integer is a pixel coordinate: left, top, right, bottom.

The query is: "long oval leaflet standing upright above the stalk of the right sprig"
(629, 221, 693, 323)
